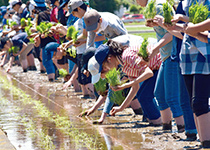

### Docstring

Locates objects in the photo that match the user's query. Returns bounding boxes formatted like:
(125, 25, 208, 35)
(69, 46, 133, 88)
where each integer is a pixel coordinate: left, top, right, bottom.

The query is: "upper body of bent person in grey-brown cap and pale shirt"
(84, 9, 127, 47)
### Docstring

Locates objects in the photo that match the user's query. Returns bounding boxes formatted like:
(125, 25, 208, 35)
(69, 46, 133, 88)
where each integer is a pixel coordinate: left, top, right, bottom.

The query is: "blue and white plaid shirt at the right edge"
(180, 0, 210, 74)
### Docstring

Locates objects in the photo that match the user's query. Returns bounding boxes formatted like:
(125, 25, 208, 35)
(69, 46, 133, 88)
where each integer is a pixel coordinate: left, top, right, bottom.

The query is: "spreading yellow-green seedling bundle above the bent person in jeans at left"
(36, 22, 53, 37)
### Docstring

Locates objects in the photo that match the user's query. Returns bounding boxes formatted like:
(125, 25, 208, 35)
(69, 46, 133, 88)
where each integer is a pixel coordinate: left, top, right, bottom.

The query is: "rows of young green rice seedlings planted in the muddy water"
(0, 76, 104, 150)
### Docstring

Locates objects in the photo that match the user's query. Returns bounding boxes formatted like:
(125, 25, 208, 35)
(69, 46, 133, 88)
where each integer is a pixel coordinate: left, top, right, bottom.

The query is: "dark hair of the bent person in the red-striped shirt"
(107, 40, 124, 56)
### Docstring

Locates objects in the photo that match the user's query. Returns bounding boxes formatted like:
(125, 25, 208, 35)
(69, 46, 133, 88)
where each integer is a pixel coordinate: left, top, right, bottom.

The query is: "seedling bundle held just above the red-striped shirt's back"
(138, 38, 149, 62)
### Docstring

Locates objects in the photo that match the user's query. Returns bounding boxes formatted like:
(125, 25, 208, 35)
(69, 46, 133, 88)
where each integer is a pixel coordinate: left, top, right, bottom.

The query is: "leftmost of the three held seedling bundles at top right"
(143, 0, 157, 25)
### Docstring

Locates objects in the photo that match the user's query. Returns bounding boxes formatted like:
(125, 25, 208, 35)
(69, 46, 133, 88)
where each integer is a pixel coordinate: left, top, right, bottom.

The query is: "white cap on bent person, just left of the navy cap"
(88, 56, 101, 84)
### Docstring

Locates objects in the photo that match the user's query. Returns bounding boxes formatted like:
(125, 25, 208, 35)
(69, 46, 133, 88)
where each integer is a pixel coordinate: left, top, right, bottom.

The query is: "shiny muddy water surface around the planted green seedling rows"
(0, 74, 145, 150)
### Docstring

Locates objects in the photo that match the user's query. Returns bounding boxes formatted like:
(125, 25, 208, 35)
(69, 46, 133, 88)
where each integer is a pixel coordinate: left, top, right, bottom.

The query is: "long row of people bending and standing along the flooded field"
(0, 0, 210, 148)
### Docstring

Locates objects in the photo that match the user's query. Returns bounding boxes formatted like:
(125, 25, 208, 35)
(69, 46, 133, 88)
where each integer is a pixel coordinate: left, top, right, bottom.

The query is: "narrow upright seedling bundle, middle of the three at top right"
(163, 2, 172, 25)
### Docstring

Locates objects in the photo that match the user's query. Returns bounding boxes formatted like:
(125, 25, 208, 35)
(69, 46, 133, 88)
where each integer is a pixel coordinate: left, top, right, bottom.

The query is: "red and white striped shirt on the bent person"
(122, 45, 161, 77)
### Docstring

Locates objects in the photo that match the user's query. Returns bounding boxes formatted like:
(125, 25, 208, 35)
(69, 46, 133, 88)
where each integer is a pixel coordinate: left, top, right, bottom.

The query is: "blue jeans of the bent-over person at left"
(42, 42, 59, 74)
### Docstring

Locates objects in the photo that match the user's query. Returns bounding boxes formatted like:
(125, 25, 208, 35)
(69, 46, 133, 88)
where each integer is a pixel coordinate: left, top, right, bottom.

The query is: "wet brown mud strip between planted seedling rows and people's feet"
(1, 61, 204, 150)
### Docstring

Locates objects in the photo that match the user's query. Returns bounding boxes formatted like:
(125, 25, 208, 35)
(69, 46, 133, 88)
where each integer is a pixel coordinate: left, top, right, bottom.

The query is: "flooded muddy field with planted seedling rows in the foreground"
(0, 68, 202, 150)
